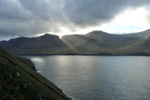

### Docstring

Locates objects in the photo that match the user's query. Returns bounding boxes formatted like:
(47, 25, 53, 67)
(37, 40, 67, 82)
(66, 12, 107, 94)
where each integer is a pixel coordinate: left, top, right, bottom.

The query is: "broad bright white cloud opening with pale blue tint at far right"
(101, 7, 150, 33)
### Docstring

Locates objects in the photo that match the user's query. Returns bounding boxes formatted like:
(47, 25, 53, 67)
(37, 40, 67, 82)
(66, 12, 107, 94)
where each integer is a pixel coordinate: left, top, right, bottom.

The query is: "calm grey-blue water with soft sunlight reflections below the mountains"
(25, 56, 150, 100)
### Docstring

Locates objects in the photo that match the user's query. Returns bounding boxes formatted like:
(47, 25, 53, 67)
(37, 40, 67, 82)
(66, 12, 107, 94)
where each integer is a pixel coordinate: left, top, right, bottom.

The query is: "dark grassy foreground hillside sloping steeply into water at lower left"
(0, 48, 71, 100)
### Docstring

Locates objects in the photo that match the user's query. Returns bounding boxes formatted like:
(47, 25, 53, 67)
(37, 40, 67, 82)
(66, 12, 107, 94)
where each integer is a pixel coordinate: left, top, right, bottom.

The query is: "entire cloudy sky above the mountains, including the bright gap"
(0, 0, 150, 40)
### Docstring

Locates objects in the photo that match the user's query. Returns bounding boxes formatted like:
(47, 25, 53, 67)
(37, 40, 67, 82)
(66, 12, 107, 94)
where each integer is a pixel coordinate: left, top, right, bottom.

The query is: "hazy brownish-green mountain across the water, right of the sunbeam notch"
(62, 30, 150, 55)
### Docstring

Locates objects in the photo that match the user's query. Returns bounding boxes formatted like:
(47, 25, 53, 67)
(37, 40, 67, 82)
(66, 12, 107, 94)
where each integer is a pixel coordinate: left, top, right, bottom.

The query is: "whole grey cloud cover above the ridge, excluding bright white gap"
(0, 0, 150, 38)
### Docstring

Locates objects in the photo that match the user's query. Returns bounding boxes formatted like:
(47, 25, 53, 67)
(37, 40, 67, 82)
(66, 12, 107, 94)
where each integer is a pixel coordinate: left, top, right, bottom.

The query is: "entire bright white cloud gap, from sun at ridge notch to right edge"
(58, 7, 150, 37)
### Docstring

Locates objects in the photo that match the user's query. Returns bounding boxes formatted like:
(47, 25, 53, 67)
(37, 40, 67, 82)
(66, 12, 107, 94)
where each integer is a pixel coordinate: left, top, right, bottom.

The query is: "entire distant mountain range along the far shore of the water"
(0, 29, 150, 55)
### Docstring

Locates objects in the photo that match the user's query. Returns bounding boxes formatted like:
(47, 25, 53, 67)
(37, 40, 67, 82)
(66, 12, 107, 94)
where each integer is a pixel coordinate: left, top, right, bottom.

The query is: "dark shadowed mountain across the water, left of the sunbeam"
(0, 34, 70, 54)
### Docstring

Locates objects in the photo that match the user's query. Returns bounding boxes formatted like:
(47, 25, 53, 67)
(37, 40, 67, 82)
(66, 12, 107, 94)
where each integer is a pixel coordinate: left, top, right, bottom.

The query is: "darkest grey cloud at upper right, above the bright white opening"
(64, 0, 150, 26)
